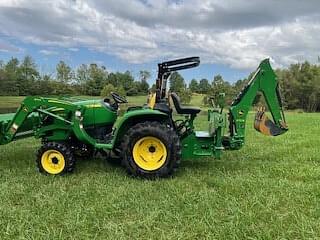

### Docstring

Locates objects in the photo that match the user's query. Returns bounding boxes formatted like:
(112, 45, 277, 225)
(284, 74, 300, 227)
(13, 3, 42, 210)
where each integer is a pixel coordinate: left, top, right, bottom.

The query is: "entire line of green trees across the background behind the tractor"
(0, 56, 320, 112)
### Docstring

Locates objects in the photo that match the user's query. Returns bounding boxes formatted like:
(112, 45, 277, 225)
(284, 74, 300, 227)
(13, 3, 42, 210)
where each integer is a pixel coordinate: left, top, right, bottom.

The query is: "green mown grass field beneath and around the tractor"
(0, 95, 320, 239)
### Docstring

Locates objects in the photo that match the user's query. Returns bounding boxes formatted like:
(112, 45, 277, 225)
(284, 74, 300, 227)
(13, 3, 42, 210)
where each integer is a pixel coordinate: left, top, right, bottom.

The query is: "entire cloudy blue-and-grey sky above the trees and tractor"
(0, 0, 320, 82)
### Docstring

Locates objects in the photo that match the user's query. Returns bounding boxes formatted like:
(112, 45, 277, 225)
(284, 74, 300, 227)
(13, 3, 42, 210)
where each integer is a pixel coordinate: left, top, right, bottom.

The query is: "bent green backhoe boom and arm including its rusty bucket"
(229, 59, 288, 147)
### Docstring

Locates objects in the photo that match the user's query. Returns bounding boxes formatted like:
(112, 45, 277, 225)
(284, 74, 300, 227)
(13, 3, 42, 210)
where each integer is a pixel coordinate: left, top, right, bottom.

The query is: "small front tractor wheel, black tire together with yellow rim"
(37, 142, 75, 175)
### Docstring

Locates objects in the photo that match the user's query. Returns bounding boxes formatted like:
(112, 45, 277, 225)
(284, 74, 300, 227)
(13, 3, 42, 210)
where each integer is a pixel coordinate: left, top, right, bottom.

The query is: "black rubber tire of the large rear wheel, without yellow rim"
(121, 121, 181, 179)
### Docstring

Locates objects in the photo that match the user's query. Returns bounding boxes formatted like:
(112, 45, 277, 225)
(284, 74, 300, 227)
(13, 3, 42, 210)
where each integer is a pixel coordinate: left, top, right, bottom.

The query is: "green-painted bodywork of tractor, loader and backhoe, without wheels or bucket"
(0, 60, 284, 162)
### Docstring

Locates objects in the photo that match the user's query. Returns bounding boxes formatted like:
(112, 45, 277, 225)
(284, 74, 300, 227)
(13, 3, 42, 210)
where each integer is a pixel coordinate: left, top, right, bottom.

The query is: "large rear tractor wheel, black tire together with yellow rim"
(122, 122, 181, 178)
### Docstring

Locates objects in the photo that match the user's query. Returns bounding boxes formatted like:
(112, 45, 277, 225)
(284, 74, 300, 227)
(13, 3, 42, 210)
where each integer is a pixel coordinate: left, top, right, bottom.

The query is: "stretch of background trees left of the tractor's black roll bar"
(0, 56, 151, 96)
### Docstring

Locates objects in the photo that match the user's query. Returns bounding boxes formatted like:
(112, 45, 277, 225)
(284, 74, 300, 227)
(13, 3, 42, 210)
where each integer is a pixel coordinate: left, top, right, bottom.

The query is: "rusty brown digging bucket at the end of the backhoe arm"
(254, 107, 287, 136)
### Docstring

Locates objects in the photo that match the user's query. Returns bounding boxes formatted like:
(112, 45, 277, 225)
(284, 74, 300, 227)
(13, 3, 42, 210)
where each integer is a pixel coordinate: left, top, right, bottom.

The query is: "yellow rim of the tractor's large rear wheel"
(133, 137, 167, 171)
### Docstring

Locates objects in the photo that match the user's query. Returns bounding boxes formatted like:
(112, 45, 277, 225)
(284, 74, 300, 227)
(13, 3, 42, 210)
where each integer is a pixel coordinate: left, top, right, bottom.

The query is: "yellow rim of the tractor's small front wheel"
(41, 150, 66, 174)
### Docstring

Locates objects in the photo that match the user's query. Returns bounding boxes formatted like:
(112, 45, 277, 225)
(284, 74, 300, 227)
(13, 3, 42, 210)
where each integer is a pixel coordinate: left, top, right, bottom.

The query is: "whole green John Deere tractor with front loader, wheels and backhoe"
(0, 57, 288, 179)
